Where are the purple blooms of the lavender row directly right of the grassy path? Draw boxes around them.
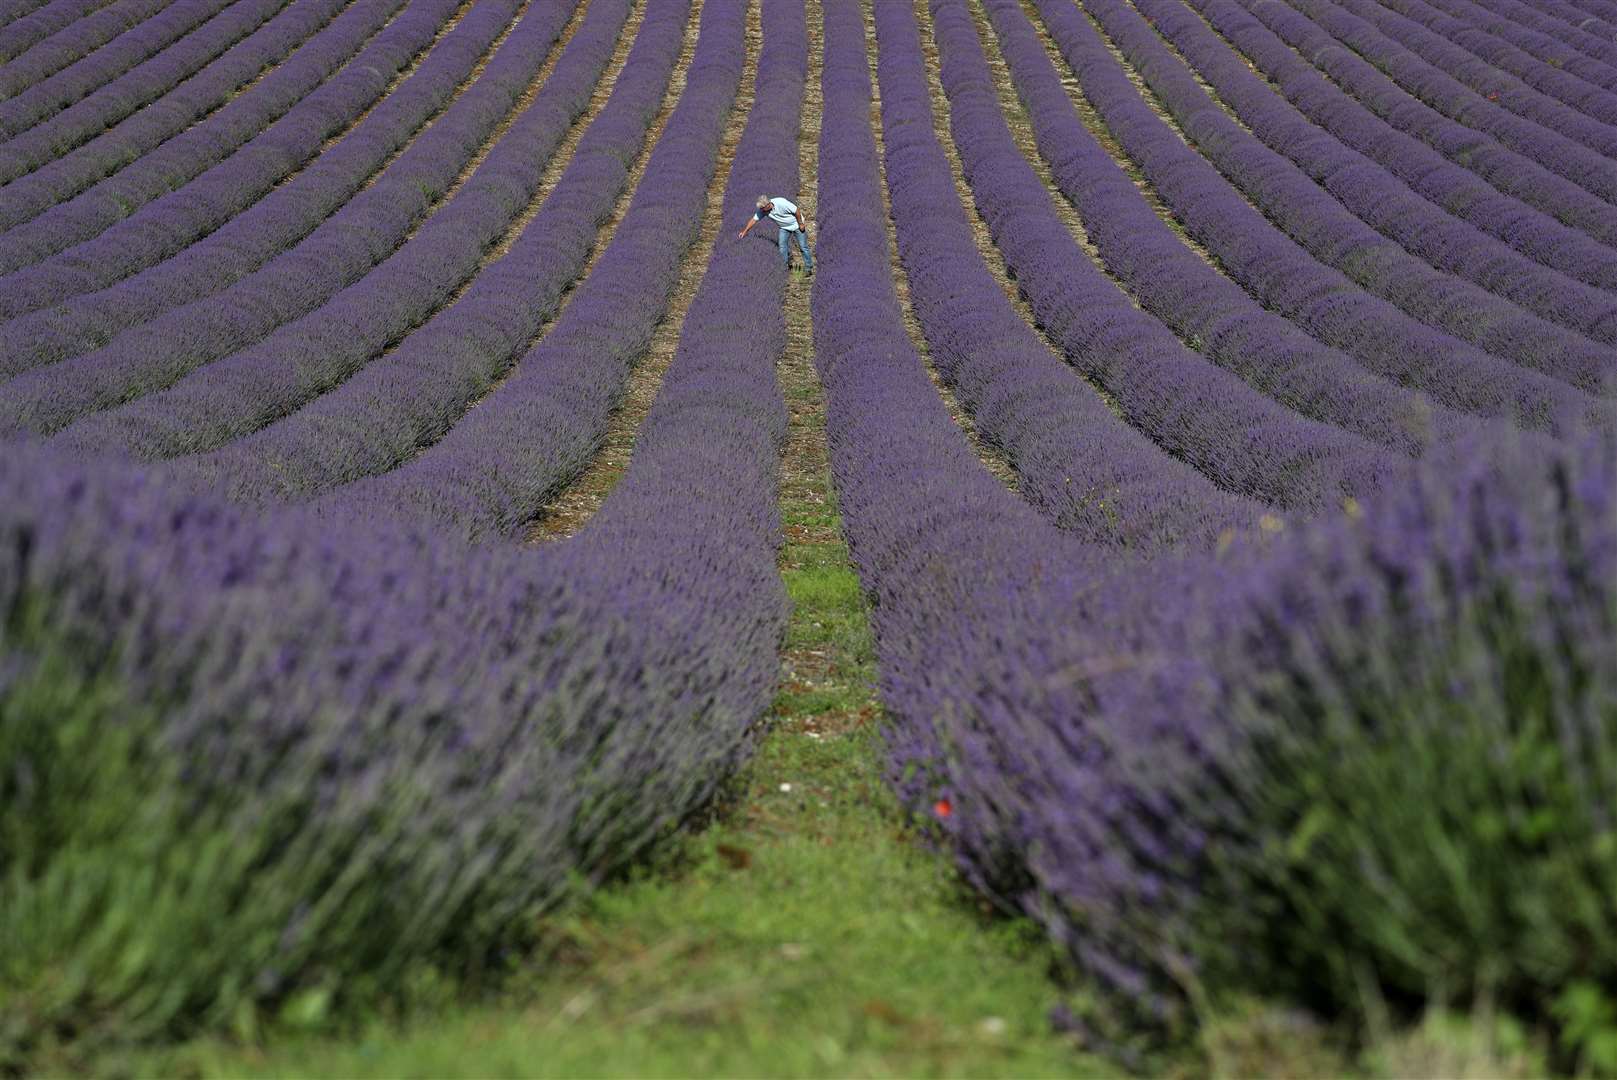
[847,0,1617,1033]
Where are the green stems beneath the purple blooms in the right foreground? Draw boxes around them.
[1200,595,1617,1075]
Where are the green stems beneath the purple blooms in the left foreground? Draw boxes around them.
[0,620,530,1072]
